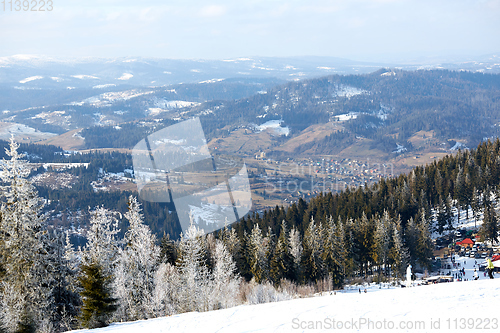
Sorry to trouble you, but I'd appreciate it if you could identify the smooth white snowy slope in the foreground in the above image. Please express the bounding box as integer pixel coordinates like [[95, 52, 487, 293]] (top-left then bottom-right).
[[71, 275, 500, 333]]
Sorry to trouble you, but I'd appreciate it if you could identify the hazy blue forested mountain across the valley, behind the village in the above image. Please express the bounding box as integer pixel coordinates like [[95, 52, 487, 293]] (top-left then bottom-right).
[[195, 69, 500, 153]]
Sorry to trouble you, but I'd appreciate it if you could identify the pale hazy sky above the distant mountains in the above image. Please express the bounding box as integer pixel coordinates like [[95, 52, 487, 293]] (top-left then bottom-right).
[[0, 0, 500, 61]]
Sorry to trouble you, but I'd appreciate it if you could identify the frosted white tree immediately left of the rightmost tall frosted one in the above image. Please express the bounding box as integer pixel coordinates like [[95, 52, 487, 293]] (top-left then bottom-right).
[[177, 224, 210, 312]]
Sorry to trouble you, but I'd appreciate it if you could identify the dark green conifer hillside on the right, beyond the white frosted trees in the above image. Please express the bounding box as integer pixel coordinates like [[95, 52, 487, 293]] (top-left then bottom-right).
[[228, 140, 500, 285]]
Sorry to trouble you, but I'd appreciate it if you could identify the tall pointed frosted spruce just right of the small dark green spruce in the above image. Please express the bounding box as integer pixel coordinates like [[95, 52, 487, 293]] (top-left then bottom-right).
[[113, 196, 160, 321]]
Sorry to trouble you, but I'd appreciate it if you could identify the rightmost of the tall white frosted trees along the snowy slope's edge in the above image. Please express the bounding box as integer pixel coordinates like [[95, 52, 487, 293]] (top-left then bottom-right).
[[211, 240, 240, 309]]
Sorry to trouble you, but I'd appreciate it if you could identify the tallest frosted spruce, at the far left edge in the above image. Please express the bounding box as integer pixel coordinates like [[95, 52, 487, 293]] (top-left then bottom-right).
[[0, 139, 51, 332]]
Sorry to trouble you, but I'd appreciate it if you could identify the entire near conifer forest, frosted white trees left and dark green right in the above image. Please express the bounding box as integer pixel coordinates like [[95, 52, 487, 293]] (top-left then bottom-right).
[[0, 136, 500, 332]]
